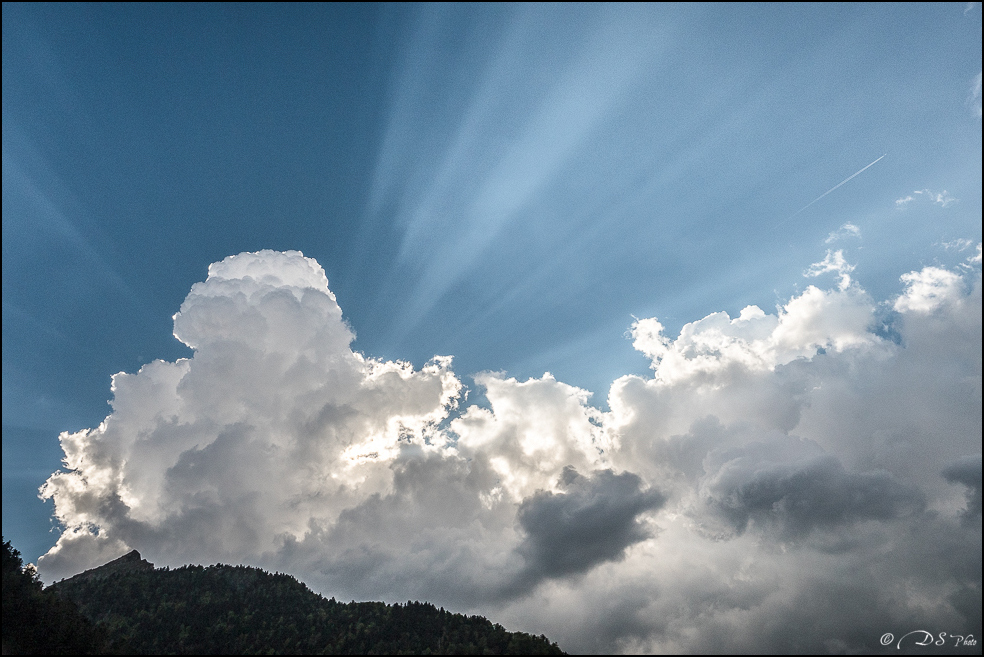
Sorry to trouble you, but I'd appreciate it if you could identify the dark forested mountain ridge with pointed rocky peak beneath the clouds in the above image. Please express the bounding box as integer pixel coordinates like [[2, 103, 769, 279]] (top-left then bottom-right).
[[3, 543, 564, 655]]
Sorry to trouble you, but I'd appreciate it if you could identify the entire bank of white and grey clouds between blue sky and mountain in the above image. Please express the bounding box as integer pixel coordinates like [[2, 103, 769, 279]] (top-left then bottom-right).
[[40, 251, 982, 652]]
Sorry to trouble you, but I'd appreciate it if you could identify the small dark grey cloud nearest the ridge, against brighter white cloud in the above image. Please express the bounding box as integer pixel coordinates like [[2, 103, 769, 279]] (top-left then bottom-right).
[[517, 467, 666, 580]]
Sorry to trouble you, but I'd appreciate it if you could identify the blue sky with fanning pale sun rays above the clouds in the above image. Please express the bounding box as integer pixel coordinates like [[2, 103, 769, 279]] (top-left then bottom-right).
[[3, 3, 981, 648]]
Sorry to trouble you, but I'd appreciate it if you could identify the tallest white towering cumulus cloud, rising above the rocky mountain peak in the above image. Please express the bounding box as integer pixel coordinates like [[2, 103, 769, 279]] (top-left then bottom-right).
[[45, 251, 461, 573]]
